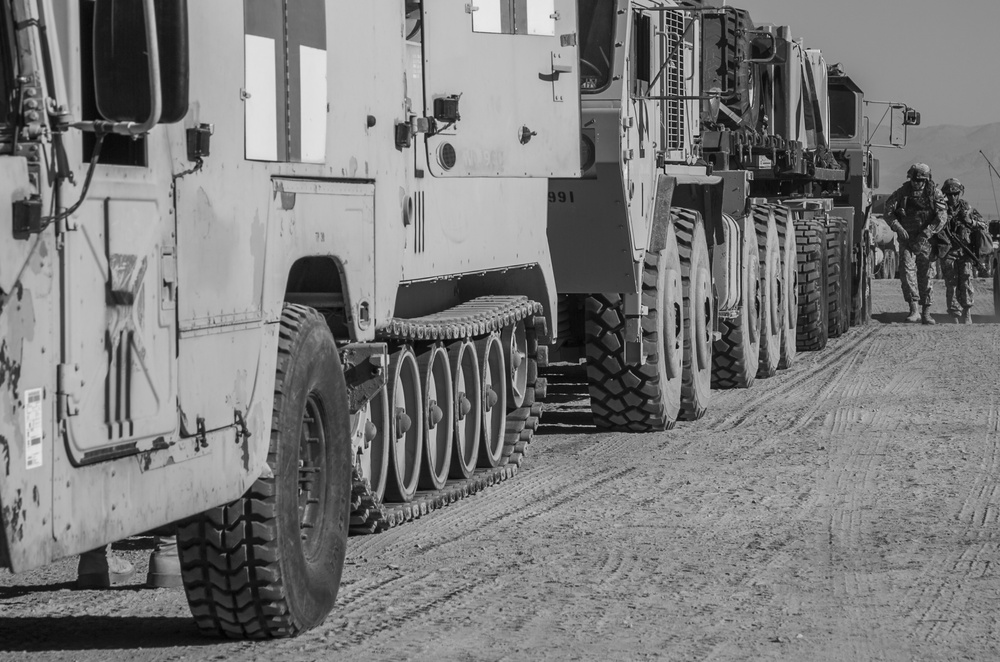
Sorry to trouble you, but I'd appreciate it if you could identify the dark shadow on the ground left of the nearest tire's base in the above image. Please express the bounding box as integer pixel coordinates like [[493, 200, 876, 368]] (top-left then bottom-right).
[[0, 616, 209, 652]]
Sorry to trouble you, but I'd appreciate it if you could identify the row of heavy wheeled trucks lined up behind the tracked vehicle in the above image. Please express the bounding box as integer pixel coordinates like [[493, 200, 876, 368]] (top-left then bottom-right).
[[548, 0, 918, 430]]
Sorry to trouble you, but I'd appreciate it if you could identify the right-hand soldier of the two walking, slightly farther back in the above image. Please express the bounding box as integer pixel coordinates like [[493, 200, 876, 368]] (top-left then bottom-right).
[[941, 179, 986, 324]]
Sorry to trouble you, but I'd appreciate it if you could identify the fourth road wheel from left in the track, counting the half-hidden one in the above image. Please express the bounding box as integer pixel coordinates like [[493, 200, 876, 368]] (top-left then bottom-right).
[[448, 340, 483, 478]]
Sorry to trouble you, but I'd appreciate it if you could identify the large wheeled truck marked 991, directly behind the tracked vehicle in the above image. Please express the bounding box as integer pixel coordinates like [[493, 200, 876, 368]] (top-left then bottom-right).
[[549, 0, 797, 430]]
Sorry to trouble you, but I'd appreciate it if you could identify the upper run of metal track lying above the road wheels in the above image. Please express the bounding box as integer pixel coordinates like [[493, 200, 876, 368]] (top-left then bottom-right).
[[378, 296, 544, 341]]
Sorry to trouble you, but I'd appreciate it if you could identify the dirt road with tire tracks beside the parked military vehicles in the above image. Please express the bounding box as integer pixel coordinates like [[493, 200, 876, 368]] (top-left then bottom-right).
[[0, 281, 1000, 662]]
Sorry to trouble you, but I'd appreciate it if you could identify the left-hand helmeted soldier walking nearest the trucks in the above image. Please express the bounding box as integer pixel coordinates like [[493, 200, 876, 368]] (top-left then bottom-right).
[[885, 163, 948, 324]]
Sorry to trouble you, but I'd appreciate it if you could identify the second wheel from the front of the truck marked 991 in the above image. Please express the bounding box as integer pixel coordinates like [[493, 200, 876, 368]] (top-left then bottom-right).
[[670, 208, 715, 421]]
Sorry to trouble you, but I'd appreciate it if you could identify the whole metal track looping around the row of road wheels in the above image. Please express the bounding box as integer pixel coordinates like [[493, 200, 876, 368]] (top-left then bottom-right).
[[350, 297, 547, 535]]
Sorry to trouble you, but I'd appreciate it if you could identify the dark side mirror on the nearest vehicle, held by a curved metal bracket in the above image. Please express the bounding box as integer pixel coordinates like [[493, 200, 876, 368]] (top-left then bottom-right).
[[94, 0, 190, 133]]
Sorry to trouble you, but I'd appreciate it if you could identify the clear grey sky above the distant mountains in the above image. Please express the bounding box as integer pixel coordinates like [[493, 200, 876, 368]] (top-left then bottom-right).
[[726, 0, 1000, 126]]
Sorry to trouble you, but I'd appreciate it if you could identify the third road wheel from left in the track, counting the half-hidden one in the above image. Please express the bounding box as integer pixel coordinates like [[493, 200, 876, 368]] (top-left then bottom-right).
[[417, 345, 455, 490]]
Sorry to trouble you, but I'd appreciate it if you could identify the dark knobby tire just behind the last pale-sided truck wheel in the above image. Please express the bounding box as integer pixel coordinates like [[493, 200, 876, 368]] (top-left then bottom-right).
[[795, 219, 828, 352]]
